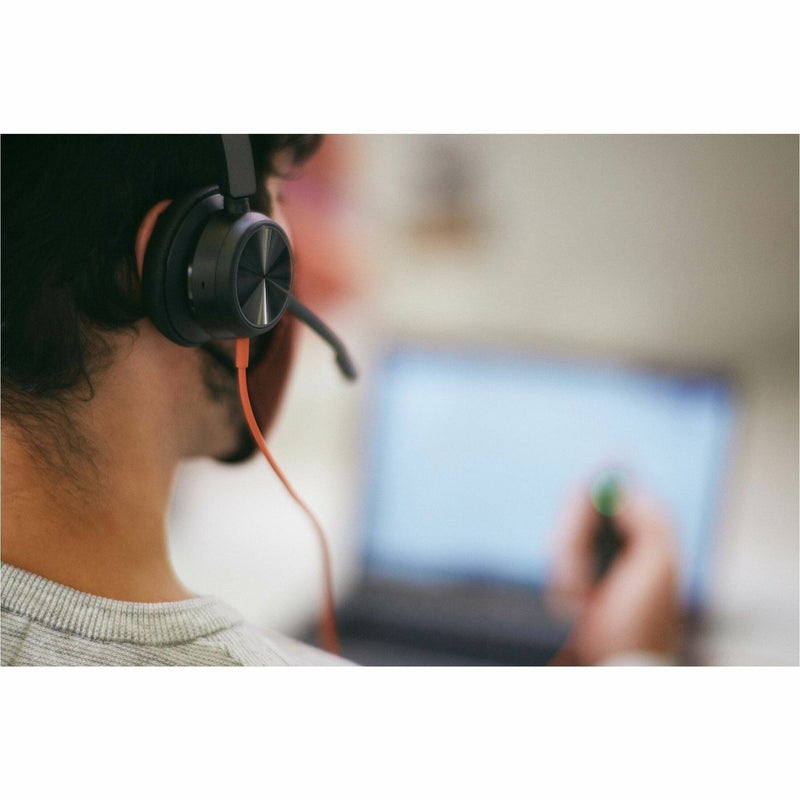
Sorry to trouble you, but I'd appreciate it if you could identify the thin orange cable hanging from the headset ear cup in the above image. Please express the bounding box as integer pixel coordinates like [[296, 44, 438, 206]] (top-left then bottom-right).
[[235, 339, 340, 655]]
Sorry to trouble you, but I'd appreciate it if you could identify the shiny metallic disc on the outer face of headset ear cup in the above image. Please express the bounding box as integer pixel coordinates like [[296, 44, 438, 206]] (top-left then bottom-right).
[[236, 225, 292, 328]]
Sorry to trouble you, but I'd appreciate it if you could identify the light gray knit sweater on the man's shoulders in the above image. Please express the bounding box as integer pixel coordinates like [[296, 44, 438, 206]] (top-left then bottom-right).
[[0, 564, 350, 666]]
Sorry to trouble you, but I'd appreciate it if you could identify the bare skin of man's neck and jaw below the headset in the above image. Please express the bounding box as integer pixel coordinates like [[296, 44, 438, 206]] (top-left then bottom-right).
[[2, 320, 247, 602]]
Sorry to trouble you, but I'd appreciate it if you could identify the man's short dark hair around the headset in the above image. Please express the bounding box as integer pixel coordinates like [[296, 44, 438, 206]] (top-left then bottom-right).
[[2, 134, 320, 421]]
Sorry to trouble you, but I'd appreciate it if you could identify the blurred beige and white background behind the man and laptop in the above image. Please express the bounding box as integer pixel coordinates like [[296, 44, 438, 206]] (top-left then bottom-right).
[[170, 135, 798, 664]]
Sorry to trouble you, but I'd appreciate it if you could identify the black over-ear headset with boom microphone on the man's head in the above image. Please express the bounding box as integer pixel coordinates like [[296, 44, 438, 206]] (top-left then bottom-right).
[[142, 134, 356, 380]]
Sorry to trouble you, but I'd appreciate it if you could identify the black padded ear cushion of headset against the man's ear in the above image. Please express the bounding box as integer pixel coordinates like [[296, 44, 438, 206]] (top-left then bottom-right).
[[142, 186, 223, 347]]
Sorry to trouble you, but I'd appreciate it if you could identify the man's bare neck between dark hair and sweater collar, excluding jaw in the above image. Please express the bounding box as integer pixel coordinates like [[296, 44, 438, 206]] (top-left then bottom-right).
[[2, 398, 191, 602]]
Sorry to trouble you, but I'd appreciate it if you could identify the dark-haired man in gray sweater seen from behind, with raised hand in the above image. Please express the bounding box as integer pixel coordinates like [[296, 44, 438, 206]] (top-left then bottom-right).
[[2, 136, 676, 665]]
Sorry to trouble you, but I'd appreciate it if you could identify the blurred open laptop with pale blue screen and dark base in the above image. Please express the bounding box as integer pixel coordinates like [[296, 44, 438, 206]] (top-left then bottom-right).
[[338, 346, 733, 666]]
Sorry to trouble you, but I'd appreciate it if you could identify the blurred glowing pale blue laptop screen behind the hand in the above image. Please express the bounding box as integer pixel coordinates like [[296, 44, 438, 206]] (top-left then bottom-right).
[[364, 349, 732, 604]]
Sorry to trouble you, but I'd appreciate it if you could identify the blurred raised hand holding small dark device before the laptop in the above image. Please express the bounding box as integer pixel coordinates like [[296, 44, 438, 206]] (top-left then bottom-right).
[[550, 489, 679, 664]]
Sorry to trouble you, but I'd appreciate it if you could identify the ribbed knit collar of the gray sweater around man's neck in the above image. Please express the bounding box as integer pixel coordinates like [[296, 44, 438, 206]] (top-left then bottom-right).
[[0, 564, 242, 645]]
